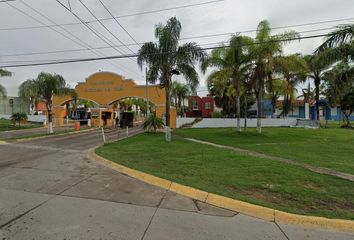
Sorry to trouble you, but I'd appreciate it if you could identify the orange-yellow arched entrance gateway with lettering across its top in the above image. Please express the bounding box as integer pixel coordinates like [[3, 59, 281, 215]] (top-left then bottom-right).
[[53, 72, 176, 128]]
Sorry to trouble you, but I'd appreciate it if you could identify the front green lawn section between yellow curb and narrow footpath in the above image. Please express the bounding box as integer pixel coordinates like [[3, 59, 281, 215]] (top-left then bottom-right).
[[96, 134, 354, 219]]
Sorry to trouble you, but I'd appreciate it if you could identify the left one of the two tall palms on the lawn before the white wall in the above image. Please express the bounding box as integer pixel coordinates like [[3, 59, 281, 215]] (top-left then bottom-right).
[[202, 36, 252, 132]]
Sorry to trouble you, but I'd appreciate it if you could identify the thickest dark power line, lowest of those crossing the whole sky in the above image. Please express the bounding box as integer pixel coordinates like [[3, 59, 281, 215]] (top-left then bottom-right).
[[0, 34, 328, 68]]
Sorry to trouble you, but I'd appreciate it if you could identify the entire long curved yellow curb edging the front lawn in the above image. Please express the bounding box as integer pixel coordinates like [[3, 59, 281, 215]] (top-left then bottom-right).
[[88, 147, 354, 232]]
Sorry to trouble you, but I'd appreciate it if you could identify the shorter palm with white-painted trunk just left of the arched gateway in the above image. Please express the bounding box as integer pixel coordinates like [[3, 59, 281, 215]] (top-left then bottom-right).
[[34, 72, 73, 134]]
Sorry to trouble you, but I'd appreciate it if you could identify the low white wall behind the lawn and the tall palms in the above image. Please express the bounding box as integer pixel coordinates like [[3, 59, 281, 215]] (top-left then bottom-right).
[[176, 118, 296, 128]]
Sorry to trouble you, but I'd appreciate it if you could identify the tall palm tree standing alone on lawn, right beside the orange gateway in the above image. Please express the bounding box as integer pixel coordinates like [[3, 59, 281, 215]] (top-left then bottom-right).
[[138, 17, 206, 141]]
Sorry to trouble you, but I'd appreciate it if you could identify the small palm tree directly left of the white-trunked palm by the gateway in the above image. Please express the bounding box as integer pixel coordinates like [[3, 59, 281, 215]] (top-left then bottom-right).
[[18, 79, 39, 113]]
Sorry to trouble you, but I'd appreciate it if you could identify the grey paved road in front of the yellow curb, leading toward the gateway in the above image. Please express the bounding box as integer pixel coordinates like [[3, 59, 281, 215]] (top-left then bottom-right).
[[0, 128, 354, 240]]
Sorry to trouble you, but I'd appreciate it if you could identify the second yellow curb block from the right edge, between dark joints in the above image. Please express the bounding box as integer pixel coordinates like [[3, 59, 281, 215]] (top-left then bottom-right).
[[206, 193, 274, 221]]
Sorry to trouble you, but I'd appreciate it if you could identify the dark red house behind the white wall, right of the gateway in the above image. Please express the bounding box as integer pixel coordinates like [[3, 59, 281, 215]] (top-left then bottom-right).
[[186, 96, 215, 118]]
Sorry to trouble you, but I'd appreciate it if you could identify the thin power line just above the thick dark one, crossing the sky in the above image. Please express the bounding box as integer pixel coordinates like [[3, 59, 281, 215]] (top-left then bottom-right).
[[0, 27, 334, 58]]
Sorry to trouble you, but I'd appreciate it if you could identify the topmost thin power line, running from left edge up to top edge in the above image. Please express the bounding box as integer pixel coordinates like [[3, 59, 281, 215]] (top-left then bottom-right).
[[0, 0, 225, 31]]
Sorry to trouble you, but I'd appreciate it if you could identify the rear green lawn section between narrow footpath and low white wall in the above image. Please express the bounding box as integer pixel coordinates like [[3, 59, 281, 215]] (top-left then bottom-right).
[[174, 128, 354, 174]]
